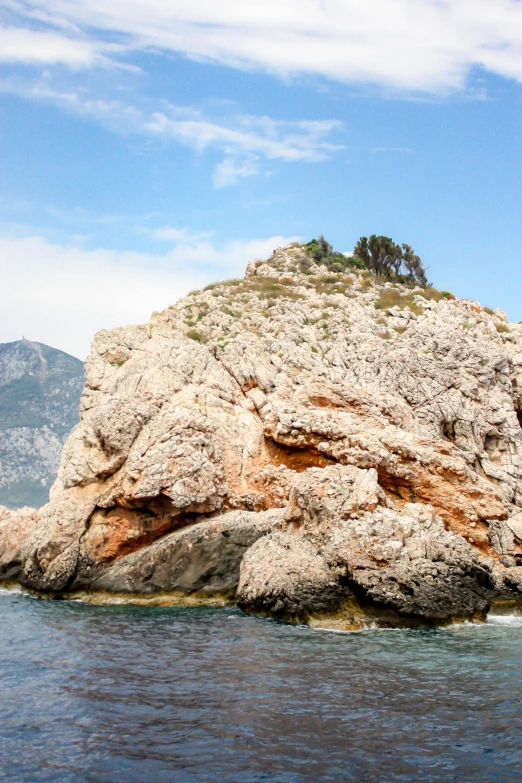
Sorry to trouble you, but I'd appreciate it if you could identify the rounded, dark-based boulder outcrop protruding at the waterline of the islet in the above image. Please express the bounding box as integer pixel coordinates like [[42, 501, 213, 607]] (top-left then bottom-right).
[[238, 466, 502, 621]]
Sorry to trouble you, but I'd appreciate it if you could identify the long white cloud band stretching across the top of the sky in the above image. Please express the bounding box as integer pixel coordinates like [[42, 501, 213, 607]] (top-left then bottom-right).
[[4, 0, 522, 92]]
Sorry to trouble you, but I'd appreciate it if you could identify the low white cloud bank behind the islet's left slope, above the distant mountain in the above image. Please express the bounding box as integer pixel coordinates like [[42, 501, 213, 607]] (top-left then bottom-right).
[[0, 230, 296, 359]]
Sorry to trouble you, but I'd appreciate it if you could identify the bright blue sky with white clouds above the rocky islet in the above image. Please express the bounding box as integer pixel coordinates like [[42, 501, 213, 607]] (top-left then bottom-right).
[[0, 0, 522, 359]]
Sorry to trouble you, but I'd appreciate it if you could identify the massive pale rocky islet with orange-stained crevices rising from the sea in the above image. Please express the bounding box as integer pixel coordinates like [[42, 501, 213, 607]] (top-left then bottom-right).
[[0, 245, 522, 627]]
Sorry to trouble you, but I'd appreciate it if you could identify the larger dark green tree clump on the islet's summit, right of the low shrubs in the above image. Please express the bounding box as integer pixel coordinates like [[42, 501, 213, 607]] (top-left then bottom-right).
[[353, 239, 429, 288]]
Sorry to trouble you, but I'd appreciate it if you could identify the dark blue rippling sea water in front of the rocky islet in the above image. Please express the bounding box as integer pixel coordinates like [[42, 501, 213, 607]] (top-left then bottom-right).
[[0, 593, 522, 783]]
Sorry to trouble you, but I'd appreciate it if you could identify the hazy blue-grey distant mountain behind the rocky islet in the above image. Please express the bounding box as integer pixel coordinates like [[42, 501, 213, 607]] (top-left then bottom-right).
[[0, 340, 83, 508]]
